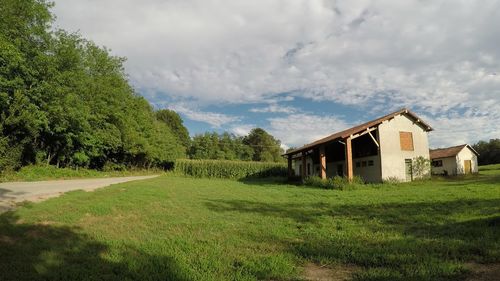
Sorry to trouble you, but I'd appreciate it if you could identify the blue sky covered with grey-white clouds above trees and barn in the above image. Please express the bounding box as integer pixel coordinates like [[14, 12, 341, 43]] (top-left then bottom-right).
[[54, 0, 500, 147]]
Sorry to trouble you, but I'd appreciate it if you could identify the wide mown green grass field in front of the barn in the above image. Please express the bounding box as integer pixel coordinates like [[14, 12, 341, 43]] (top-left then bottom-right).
[[0, 166, 500, 280]]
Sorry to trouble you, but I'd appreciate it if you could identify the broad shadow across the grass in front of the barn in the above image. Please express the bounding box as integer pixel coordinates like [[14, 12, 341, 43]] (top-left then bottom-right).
[[206, 199, 500, 281]]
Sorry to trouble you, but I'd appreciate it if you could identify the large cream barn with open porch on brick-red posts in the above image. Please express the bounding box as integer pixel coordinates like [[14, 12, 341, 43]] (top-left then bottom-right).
[[284, 108, 432, 182]]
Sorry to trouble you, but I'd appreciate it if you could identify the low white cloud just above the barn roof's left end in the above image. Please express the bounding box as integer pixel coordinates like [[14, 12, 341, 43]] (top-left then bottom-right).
[[269, 114, 353, 147]]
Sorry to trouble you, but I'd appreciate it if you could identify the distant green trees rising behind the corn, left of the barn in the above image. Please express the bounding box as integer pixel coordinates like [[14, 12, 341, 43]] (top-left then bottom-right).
[[188, 128, 284, 162]]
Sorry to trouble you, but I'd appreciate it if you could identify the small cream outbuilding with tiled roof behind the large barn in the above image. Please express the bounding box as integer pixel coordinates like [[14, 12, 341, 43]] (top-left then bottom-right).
[[429, 144, 479, 175]]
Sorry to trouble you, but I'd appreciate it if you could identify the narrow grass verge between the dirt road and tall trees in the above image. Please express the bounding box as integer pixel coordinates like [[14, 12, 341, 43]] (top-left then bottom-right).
[[0, 165, 161, 182]]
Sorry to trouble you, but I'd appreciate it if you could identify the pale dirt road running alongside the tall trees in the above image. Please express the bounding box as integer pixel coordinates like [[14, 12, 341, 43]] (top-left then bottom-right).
[[0, 176, 157, 213]]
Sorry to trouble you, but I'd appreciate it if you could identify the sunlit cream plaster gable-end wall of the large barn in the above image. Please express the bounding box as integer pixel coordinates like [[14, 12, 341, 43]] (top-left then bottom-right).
[[379, 115, 429, 181]]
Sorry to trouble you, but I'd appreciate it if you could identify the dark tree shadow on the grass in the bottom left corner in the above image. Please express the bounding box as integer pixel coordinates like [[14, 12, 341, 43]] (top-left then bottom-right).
[[0, 212, 188, 281]]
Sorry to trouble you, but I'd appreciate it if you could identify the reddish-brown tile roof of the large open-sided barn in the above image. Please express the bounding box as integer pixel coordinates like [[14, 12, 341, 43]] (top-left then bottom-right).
[[284, 108, 433, 155]]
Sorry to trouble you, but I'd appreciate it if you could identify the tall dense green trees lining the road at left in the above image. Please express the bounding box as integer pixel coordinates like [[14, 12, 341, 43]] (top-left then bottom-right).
[[0, 0, 185, 171]]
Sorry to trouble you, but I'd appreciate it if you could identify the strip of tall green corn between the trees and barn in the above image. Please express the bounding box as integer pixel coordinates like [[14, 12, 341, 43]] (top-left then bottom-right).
[[174, 159, 287, 179]]
